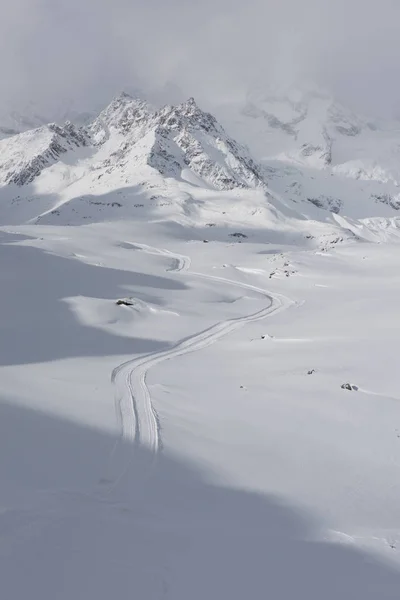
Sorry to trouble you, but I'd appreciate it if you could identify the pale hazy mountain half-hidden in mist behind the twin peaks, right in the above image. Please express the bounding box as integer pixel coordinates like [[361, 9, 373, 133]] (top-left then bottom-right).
[[217, 88, 400, 223]]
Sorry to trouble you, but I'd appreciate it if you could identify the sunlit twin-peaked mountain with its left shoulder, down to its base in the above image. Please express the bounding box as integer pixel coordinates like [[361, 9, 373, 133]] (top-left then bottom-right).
[[0, 93, 296, 235]]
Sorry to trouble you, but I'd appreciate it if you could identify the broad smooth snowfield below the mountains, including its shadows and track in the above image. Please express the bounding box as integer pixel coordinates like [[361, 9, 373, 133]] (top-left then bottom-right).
[[0, 221, 400, 600]]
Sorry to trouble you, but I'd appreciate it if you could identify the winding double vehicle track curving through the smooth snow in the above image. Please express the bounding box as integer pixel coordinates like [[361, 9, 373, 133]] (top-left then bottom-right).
[[104, 242, 294, 487]]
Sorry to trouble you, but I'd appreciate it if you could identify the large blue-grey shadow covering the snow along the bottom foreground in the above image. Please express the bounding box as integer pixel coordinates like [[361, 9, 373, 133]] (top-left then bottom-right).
[[0, 394, 400, 600]]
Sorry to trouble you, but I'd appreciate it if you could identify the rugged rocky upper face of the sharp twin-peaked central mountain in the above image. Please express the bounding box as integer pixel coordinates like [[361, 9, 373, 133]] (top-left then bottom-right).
[[90, 94, 265, 190]]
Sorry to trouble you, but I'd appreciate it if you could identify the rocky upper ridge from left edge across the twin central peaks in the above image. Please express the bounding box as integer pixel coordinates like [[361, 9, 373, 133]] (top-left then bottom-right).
[[0, 94, 265, 189]]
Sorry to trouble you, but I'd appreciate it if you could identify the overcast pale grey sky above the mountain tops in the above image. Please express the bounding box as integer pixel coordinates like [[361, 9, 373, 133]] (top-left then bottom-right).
[[0, 0, 400, 115]]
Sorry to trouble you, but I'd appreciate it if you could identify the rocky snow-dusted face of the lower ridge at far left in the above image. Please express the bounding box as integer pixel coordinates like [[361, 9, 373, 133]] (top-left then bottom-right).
[[0, 122, 90, 186]]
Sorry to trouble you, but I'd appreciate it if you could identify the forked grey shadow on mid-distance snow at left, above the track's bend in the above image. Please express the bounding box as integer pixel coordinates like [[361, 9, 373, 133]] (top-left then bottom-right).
[[0, 234, 186, 365]]
